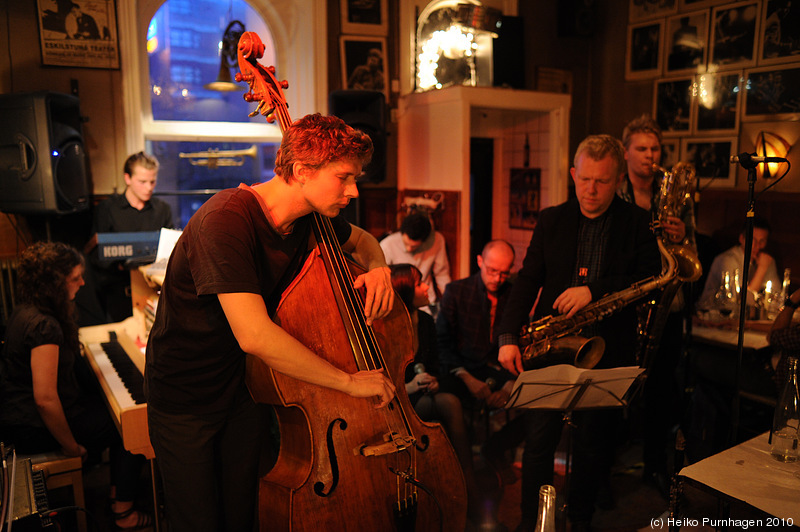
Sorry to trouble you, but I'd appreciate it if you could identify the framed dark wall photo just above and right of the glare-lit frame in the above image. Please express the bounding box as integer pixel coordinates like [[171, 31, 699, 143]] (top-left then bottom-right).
[[708, 2, 759, 68]]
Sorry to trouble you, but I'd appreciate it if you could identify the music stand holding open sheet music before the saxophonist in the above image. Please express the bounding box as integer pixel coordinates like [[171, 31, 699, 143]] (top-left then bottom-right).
[[505, 364, 644, 529]]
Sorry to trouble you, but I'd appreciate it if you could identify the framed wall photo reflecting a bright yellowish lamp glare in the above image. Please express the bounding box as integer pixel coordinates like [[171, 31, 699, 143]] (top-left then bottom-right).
[[694, 71, 742, 135]]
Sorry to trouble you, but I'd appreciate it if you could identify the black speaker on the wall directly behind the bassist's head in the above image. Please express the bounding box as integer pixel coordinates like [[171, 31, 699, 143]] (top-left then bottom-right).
[[329, 90, 386, 183]]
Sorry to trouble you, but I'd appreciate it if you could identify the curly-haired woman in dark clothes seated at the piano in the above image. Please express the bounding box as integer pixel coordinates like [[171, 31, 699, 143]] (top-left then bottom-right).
[[0, 242, 152, 530]]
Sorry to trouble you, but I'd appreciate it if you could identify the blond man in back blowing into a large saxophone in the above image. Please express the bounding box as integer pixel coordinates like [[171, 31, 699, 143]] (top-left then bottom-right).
[[617, 114, 699, 499]]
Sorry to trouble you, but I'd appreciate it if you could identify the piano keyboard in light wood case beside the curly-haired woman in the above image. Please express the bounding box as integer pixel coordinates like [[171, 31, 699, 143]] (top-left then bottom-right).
[[80, 318, 155, 459]]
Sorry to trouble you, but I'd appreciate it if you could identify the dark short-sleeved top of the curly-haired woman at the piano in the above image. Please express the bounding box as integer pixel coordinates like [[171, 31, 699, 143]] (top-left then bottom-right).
[[0, 304, 81, 427]]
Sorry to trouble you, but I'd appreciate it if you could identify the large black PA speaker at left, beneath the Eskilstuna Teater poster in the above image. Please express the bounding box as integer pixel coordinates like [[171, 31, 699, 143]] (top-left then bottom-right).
[[0, 92, 89, 214]]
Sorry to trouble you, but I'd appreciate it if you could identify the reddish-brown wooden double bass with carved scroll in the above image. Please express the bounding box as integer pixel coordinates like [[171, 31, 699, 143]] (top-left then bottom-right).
[[236, 32, 467, 532]]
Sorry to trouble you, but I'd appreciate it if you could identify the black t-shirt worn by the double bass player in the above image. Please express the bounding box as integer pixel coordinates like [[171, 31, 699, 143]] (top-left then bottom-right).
[[145, 186, 351, 414]]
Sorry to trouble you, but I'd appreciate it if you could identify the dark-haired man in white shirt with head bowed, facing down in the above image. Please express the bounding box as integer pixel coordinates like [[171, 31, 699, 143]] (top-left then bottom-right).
[[381, 212, 450, 316]]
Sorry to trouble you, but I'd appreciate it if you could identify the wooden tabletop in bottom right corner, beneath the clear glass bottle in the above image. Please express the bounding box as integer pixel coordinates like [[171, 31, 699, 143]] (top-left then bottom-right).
[[679, 432, 800, 528]]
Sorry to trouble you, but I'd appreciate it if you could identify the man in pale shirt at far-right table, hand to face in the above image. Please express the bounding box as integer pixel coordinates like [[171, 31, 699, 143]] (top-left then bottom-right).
[[697, 216, 781, 308]]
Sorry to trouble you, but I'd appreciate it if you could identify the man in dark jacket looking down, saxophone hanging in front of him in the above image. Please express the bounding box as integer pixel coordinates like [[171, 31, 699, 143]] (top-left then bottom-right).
[[498, 135, 661, 531]]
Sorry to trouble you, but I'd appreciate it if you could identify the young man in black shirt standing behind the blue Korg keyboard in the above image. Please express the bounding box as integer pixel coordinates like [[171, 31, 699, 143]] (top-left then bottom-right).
[[92, 152, 174, 323]]
